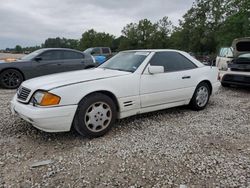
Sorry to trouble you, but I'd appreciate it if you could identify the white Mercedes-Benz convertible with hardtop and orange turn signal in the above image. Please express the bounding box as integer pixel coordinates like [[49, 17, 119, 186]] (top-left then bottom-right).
[[11, 50, 220, 137]]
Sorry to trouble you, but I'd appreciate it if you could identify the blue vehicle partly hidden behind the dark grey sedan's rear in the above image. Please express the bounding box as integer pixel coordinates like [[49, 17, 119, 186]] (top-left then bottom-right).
[[84, 47, 112, 64]]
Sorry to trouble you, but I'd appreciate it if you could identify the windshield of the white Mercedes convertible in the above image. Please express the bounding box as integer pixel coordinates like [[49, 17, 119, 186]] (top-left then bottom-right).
[[99, 52, 149, 72]]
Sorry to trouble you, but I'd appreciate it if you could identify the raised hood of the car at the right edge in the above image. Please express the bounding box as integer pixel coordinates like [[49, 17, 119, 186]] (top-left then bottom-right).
[[232, 37, 250, 57]]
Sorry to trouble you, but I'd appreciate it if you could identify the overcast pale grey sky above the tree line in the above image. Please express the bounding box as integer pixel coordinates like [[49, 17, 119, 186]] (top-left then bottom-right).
[[0, 0, 193, 49]]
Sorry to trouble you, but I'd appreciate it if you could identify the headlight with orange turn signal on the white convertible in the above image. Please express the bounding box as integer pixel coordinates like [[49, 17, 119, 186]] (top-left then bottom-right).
[[33, 91, 61, 106]]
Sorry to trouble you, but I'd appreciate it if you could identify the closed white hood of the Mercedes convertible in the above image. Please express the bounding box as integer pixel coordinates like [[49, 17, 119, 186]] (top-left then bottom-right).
[[22, 68, 132, 91]]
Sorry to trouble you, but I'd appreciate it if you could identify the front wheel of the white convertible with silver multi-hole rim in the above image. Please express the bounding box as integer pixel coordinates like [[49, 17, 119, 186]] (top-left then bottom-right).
[[73, 93, 117, 138]]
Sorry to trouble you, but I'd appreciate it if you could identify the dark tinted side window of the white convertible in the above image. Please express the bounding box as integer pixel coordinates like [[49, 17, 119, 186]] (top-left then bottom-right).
[[150, 52, 197, 72]]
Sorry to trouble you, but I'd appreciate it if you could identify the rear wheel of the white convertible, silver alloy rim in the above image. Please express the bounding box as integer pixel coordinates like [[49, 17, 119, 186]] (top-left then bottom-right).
[[189, 82, 211, 111]]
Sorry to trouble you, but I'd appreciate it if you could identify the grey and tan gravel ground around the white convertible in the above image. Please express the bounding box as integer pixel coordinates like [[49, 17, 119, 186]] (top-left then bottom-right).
[[0, 88, 250, 187]]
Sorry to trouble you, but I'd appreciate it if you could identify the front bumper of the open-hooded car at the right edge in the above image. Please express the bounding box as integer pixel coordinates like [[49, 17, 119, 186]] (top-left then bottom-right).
[[221, 71, 250, 87]]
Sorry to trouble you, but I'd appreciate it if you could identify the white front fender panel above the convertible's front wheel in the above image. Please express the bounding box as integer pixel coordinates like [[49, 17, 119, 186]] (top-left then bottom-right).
[[50, 74, 140, 105]]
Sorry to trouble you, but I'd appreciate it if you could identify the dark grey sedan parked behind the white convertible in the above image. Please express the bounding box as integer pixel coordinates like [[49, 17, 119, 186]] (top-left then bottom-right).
[[0, 48, 96, 89]]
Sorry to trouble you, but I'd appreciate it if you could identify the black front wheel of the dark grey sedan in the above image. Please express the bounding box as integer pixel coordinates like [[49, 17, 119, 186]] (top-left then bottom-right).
[[0, 69, 24, 89]]
